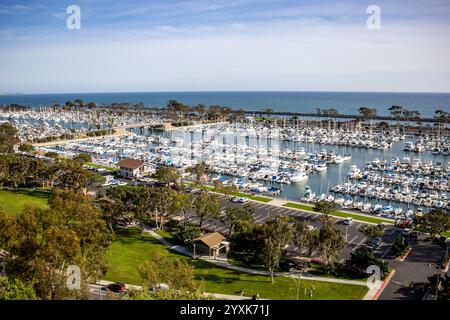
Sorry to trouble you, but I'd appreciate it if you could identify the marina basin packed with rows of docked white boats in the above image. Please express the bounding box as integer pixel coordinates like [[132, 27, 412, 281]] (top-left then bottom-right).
[[33, 123, 450, 218]]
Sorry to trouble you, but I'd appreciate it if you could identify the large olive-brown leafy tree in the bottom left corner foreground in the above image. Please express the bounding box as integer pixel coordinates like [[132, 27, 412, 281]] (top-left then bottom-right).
[[0, 190, 111, 299]]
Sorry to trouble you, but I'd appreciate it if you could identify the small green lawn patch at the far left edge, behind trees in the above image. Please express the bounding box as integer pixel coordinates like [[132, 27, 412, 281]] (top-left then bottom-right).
[[0, 189, 50, 214]]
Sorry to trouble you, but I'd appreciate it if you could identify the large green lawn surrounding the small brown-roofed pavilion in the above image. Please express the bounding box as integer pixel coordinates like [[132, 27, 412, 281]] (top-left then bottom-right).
[[104, 228, 368, 300]]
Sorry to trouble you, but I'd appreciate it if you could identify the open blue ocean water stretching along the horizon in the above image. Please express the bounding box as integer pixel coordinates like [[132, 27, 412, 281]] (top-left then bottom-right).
[[0, 92, 450, 117]]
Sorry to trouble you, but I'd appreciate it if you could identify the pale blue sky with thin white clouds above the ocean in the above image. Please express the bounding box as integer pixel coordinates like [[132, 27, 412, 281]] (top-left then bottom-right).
[[0, 0, 450, 93]]
